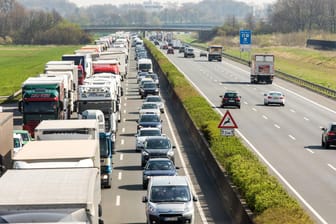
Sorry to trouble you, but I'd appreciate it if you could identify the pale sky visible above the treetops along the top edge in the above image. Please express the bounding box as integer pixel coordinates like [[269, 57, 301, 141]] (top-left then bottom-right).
[[69, 0, 276, 7]]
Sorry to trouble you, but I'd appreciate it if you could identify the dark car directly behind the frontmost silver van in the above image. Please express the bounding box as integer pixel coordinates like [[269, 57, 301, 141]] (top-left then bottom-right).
[[142, 158, 179, 189]]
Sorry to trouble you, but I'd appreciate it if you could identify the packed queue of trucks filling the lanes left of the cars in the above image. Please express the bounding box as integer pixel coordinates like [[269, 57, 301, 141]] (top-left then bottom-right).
[[0, 33, 129, 224]]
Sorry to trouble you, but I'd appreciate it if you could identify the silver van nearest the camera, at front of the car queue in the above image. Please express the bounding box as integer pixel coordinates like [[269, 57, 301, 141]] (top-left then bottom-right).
[[142, 176, 197, 223]]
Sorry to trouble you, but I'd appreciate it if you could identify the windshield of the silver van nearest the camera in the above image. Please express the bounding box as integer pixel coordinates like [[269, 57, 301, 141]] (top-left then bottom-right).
[[150, 186, 191, 202]]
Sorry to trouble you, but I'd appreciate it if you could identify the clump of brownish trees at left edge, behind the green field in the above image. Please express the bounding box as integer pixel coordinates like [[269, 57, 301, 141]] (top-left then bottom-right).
[[0, 0, 91, 44]]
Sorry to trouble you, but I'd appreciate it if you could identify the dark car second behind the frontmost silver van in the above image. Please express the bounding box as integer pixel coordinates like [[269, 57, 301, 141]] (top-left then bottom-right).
[[141, 136, 176, 167]]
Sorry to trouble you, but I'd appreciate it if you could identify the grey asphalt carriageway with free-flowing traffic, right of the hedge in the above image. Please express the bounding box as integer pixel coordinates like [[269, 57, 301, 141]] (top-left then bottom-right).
[[163, 46, 336, 223]]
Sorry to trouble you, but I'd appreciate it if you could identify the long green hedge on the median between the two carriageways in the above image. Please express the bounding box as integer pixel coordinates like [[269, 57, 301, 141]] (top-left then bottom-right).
[[145, 41, 313, 224]]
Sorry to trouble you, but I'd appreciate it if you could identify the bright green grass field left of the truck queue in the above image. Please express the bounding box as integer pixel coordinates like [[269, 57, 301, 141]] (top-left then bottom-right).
[[0, 45, 79, 96]]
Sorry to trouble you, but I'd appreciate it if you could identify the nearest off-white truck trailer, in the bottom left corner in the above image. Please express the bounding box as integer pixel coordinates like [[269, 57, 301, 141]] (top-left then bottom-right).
[[0, 168, 104, 224]]
